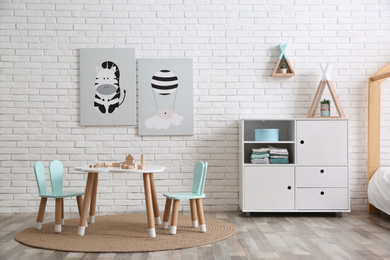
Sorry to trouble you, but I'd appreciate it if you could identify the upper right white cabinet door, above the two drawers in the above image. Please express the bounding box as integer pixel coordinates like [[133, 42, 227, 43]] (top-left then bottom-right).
[[297, 120, 348, 164]]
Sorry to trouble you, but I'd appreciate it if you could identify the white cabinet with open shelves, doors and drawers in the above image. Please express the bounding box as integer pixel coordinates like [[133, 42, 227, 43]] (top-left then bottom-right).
[[239, 119, 350, 214]]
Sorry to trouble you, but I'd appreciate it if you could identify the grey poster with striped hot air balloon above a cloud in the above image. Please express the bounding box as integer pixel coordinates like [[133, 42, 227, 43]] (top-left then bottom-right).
[[138, 59, 193, 135]]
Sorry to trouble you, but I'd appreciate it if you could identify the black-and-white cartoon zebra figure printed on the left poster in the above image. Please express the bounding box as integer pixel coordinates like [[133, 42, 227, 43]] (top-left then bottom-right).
[[94, 61, 126, 114]]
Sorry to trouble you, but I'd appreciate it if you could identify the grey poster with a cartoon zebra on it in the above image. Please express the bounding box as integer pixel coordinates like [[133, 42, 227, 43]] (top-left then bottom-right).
[[80, 48, 136, 125]]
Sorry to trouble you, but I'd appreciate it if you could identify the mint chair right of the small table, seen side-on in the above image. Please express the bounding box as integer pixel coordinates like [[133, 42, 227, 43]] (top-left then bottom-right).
[[163, 161, 207, 235]]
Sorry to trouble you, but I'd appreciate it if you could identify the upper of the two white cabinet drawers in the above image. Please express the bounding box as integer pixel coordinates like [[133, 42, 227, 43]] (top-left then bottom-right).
[[297, 167, 348, 188]]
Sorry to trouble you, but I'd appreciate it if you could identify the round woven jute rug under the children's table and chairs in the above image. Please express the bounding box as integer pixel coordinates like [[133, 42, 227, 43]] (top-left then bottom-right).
[[15, 214, 236, 253]]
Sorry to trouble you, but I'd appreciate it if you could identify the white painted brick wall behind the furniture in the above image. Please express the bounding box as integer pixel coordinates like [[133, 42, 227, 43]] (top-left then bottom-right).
[[0, 0, 390, 213]]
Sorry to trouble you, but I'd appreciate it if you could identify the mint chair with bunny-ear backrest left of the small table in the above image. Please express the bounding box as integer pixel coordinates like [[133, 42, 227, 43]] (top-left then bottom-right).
[[34, 160, 84, 233]]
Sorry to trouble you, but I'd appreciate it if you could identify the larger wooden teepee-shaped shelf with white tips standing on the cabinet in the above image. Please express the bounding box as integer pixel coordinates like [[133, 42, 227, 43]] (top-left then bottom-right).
[[307, 63, 345, 118]]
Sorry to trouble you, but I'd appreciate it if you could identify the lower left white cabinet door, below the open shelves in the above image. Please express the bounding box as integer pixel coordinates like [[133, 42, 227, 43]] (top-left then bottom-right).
[[244, 166, 294, 211]]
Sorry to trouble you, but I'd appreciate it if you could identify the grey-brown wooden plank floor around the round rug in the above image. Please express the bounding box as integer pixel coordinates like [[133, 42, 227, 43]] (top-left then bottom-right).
[[0, 212, 390, 260]]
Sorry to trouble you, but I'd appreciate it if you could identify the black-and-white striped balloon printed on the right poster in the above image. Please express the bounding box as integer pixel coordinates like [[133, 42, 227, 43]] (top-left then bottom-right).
[[152, 70, 179, 95]]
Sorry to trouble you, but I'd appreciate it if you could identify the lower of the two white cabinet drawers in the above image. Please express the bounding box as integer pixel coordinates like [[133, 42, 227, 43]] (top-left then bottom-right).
[[297, 188, 349, 210]]
